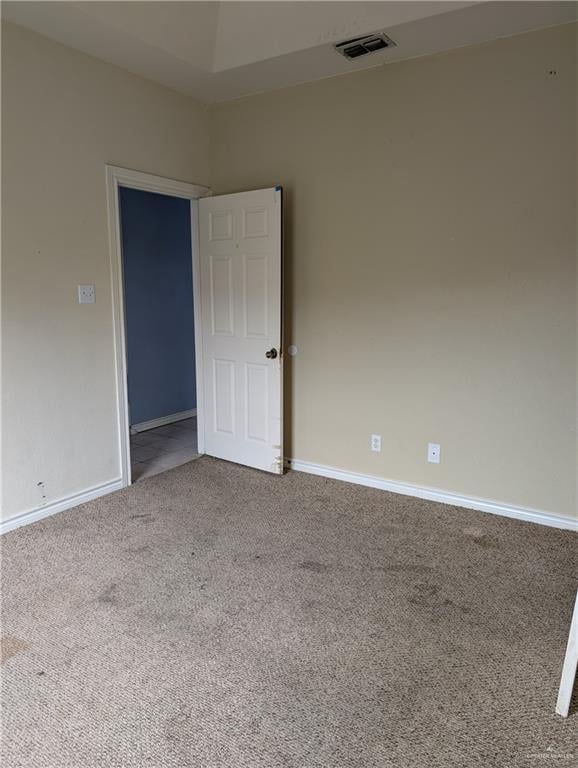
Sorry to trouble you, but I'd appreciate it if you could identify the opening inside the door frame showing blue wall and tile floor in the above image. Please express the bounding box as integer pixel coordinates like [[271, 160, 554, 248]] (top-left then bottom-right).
[[119, 186, 198, 482]]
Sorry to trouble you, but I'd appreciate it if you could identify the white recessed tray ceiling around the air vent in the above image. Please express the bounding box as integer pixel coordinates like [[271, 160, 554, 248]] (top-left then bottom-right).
[[2, 0, 577, 102]]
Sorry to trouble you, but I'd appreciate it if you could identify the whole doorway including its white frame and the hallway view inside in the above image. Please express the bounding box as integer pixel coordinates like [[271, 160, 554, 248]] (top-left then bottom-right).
[[107, 166, 209, 486]]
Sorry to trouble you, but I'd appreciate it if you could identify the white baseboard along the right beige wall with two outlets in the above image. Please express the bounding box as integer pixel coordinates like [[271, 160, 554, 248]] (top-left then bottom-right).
[[285, 459, 578, 531]]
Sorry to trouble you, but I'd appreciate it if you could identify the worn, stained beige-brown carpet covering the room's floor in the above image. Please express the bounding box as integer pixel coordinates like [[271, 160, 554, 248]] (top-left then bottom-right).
[[2, 458, 578, 768]]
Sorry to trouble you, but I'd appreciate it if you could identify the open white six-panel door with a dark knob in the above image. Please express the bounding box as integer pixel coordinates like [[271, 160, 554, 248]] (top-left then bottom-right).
[[199, 188, 283, 474]]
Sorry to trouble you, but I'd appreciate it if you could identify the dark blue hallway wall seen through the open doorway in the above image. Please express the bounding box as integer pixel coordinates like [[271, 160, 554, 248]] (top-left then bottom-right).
[[120, 188, 196, 424]]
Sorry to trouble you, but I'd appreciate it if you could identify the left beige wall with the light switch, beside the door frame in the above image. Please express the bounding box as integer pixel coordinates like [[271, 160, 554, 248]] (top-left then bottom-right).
[[2, 24, 208, 519]]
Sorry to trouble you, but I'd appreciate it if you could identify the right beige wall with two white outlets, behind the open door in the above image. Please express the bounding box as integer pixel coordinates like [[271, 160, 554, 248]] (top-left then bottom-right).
[[211, 26, 576, 516]]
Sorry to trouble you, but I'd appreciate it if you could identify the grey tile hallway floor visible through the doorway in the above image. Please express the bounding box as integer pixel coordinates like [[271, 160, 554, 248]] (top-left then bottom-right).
[[130, 418, 199, 476]]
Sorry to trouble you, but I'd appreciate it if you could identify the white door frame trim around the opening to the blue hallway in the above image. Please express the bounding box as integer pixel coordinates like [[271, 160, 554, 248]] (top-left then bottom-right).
[[106, 165, 211, 488]]
